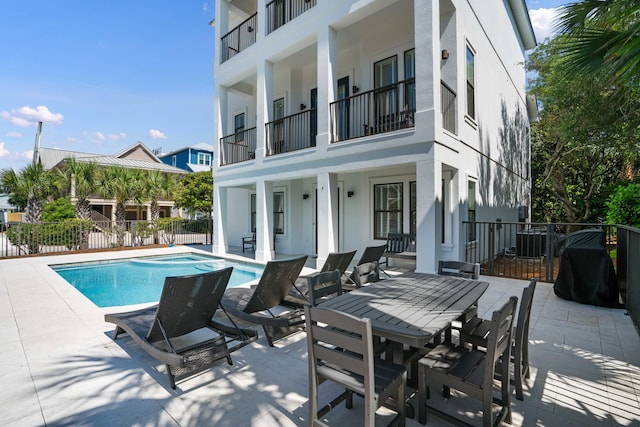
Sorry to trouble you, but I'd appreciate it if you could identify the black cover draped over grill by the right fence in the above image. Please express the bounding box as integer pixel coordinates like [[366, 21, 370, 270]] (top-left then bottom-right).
[[553, 230, 621, 307]]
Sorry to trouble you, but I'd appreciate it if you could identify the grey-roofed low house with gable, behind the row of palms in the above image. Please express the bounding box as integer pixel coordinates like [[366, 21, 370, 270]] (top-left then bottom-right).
[[34, 142, 185, 221]]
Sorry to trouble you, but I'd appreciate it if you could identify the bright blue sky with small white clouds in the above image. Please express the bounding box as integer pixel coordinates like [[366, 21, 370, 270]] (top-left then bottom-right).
[[0, 0, 569, 170]]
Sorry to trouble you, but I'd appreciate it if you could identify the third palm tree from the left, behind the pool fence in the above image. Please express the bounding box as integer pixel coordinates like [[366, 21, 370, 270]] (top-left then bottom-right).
[[97, 166, 142, 246]]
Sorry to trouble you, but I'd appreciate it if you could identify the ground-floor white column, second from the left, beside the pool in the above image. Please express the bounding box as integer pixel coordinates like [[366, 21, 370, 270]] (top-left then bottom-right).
[[256, 181, 275, 261]]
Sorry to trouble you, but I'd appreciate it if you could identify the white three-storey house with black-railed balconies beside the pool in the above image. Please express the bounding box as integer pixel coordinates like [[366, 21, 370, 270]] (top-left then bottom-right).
[[212, 0, 536, 272]]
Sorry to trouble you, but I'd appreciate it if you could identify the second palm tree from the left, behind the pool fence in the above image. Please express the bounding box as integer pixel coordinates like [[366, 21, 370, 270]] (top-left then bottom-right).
[[58, 159, 99, 220]]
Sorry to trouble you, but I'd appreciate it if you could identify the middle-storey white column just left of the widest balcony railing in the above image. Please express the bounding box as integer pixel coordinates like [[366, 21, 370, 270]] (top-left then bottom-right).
[[316, 26, 337, 150]]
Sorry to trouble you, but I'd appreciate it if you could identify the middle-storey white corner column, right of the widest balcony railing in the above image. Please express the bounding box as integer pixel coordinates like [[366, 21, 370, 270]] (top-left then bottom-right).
[[414, 1, 440, 141]]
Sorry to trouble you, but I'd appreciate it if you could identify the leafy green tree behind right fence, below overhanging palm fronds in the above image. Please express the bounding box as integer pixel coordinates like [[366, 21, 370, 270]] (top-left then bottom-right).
[[527, 36, 640, 222]]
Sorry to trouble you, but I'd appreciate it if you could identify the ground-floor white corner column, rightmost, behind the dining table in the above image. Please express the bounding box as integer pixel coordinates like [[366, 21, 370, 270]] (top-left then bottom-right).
[[416, 155, 442, 273]]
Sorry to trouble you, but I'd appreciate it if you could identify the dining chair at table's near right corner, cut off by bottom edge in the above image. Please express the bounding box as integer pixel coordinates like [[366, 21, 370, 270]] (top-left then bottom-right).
[[418, 297, 518, 427]]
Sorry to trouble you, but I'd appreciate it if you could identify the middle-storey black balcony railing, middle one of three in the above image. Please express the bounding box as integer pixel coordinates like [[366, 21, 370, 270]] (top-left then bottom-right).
[[265, 108, 318, 156]]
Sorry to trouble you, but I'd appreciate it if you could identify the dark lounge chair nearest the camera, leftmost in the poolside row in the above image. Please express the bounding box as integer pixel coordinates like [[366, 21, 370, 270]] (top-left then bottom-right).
[[104, 267, 258, 389]]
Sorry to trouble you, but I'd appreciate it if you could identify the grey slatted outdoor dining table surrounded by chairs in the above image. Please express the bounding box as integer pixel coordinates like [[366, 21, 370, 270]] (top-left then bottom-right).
[[320, 272, 489, 363]]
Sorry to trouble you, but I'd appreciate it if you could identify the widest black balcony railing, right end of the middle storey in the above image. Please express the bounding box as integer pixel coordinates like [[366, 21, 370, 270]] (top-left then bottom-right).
[[330, 79, 416, 142]]
